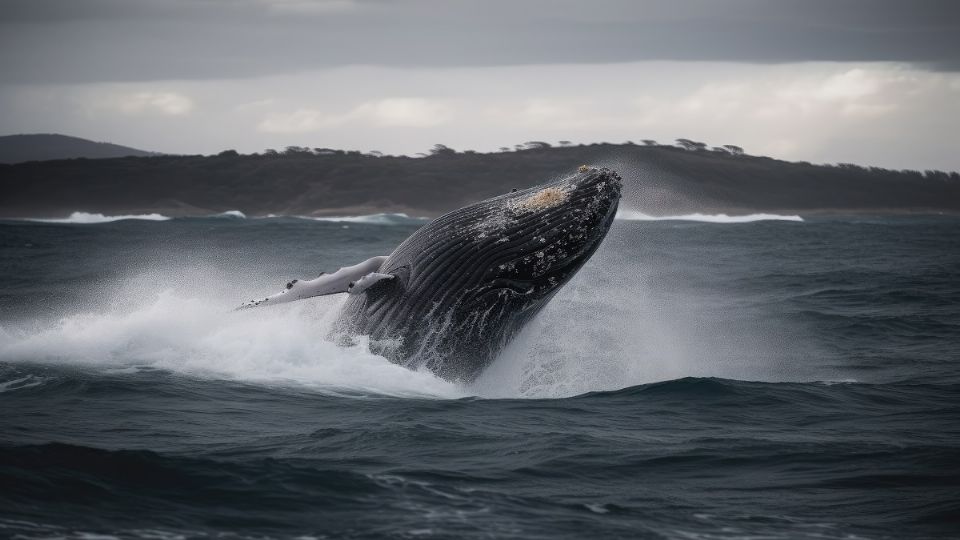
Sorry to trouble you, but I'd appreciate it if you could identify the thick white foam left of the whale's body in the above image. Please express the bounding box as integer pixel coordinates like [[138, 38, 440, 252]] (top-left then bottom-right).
[[0, 291, 465, 398]]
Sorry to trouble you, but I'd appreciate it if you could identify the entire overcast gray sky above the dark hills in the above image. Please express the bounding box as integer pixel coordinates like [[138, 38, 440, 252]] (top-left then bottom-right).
[[0, 0, 960, 170]]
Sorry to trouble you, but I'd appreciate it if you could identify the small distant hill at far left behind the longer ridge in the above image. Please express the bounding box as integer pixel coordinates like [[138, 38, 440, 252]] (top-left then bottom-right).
[[0, 134, 156, 163]]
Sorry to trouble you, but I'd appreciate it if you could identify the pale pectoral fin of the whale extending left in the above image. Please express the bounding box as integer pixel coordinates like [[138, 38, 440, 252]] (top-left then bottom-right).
[[237, 256, 393, 309]]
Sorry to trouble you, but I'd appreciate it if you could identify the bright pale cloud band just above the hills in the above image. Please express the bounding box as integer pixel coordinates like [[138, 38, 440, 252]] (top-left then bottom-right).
[[0, 62, 960, 170]]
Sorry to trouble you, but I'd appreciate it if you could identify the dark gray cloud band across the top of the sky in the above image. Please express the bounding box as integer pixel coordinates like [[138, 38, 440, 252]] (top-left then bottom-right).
[[0, 0, 960, 84]]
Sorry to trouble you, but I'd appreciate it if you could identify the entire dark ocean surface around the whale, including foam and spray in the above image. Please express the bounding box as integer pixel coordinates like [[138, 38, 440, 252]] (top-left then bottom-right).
[[0, 212, 960, 540]]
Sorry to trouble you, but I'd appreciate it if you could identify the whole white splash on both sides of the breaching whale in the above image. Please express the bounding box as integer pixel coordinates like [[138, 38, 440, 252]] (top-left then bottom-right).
[[0, 217, 816, 398]]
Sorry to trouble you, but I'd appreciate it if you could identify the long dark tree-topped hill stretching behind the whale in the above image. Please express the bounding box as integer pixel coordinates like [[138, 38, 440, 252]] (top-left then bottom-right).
[[0, 143, 960, 217]]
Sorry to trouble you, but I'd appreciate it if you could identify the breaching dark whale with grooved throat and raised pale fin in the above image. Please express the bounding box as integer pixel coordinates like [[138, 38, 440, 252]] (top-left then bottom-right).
[[239, 166, 621, 382]]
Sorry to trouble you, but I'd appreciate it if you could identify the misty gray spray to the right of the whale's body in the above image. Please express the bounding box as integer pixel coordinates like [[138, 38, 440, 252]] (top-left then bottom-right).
[[475, 219, 816, 398]]
